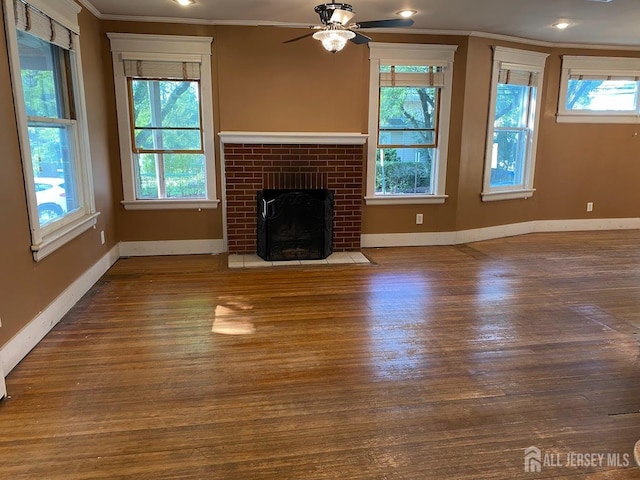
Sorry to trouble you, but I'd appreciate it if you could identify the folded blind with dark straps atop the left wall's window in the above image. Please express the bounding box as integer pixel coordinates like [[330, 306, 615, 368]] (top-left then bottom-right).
[[14, 0, 78, 50]]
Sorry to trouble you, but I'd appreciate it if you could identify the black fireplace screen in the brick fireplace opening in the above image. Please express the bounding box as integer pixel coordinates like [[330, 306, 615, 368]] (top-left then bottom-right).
[[257, 189, 333, 261]]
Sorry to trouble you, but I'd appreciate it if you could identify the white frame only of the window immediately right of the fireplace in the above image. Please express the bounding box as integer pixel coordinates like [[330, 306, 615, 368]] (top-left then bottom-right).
[[365, 42, 458, 205]]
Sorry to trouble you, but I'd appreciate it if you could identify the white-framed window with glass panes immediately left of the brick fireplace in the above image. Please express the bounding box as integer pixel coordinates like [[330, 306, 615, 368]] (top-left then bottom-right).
[[108, 33, 218, 209]]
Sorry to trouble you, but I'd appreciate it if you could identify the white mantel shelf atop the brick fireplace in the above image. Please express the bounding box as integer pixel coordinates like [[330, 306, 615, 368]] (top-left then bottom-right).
[[218, 132, 369, 145]]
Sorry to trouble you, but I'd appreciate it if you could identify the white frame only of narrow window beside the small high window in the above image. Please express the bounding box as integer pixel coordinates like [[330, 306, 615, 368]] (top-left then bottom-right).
[[481, 46, 549, 202]]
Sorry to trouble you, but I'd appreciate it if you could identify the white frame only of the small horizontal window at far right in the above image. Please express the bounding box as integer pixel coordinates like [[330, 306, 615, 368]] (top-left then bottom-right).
[[556, 55, 640, 123]]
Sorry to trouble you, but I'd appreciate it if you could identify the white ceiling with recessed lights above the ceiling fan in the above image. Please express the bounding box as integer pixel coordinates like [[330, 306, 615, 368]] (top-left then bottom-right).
[[79, 0, 640, 47]]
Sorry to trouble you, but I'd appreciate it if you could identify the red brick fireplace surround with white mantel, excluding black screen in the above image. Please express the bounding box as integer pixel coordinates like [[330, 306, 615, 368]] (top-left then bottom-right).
[[220, 132, 366, 254]]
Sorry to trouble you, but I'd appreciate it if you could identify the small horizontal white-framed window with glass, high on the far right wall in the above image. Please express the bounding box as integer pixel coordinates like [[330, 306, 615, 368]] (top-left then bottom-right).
[[557, 55, 640, 123]]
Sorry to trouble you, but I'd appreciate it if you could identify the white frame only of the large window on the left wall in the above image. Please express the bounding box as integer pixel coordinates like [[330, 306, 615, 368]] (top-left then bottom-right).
[[3, 0, 99, 262]]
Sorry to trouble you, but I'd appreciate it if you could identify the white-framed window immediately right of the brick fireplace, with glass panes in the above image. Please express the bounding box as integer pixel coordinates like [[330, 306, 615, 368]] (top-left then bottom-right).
[[365, 42, 456, 204]]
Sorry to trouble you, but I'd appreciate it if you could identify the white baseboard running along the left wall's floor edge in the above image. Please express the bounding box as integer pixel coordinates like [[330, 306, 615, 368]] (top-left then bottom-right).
[[0, 245, 119, 375]]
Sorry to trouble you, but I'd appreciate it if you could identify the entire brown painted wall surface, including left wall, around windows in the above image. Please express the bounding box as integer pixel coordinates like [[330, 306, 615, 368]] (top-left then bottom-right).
[[0, 6, 640, 352]]
